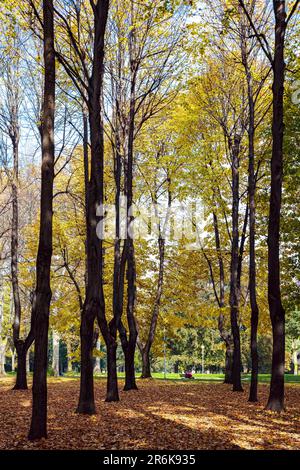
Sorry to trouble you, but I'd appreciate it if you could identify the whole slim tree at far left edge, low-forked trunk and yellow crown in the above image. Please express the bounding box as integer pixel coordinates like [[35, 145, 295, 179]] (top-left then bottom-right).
[[0, 4, 33, 390]]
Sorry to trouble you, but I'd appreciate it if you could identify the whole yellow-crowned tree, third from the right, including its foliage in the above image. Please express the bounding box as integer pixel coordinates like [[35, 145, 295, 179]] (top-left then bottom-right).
[[188, 59, 248, 391]]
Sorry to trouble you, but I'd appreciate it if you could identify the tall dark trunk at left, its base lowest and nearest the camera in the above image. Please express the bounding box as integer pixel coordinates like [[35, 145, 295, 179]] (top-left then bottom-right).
[[28, 0, 55, 440]]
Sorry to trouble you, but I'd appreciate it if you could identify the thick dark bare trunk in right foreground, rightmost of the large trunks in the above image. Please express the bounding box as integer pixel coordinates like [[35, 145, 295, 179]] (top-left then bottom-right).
[[267, 0, 286, 412]]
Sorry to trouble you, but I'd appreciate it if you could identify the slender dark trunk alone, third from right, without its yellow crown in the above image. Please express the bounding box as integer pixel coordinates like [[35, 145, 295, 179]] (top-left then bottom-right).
[[230, 135, 243, 392]]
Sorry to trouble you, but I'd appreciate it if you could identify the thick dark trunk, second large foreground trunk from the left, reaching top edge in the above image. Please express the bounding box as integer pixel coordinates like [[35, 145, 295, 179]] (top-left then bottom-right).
[[77, 0, 109, 414]]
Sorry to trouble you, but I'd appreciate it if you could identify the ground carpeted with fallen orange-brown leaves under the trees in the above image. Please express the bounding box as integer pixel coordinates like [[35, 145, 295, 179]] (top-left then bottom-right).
[[0, 377, 300, 450]]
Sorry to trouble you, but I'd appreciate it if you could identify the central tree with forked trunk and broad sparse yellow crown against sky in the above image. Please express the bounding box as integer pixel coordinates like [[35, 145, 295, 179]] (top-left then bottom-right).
[[106, 0, 183, 390]]
